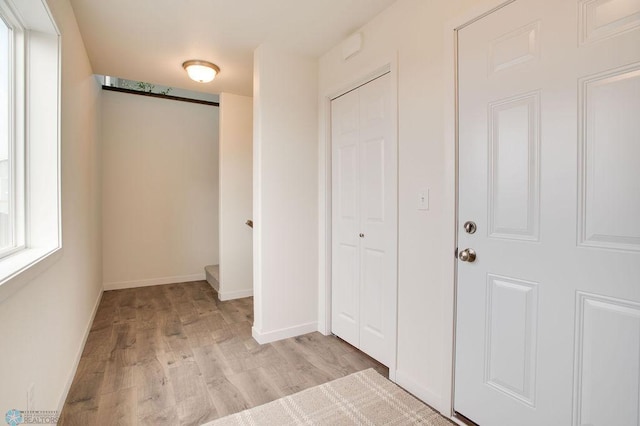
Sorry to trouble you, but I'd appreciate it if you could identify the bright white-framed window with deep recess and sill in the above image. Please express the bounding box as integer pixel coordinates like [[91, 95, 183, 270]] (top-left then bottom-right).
[[0, 0, 61, 301]]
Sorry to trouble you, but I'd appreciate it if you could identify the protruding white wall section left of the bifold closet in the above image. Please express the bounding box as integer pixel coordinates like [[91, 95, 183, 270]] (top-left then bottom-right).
[[253, 44, 318, 343]]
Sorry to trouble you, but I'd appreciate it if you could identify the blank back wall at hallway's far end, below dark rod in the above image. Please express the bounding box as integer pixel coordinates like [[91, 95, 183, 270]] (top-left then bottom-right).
[[102, 92, 219, 290]]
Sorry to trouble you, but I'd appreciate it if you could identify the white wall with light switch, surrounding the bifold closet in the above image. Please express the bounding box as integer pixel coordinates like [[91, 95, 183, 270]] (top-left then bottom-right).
[[319, 0, 492, 414]]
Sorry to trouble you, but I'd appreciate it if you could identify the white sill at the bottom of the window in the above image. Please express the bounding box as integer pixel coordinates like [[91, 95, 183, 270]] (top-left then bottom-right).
[[0, 247, 62, 303]]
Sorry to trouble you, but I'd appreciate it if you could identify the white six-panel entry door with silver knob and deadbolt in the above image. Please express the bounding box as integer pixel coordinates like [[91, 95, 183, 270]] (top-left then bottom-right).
[[454, 0, 640, 426]]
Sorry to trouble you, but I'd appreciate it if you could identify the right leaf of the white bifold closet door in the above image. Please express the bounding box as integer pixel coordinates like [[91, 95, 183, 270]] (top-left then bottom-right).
[[358, 74, 398, 365]]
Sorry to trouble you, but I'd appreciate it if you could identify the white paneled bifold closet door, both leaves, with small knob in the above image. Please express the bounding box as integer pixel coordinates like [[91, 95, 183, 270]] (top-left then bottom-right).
[[331, 74, 397, 365]]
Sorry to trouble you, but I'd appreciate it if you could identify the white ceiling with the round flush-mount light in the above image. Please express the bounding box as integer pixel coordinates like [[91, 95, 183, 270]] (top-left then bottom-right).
[[71, 0, 395, 96]]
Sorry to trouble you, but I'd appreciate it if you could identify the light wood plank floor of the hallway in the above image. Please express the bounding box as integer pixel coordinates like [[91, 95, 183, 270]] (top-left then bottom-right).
[[59, 281, 388, 426]]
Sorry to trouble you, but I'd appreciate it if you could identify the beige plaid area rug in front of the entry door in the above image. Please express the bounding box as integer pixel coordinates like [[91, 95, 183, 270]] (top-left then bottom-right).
[[205, 368, 453, 426]]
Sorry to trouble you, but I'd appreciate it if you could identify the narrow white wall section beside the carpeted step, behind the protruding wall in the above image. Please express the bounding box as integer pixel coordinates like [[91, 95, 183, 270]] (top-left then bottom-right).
[[218, 93, 253, 300]]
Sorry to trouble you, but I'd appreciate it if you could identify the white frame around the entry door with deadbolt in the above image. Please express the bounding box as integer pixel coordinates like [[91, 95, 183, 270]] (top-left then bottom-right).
[[443, 0, 516, 420]]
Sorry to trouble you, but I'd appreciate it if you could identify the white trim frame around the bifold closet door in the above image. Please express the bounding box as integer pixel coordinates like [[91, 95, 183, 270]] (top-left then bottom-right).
[[318, 58, 399, 382]]
